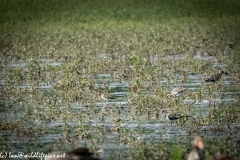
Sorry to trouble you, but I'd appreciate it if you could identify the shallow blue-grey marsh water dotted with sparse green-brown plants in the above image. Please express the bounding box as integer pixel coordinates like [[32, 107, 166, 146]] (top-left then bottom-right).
[[0, 52, 240, 159]]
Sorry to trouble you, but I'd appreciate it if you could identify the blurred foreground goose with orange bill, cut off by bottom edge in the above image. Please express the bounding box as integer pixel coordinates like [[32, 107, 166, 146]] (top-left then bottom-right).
[[187, 136, 240, 160]]
